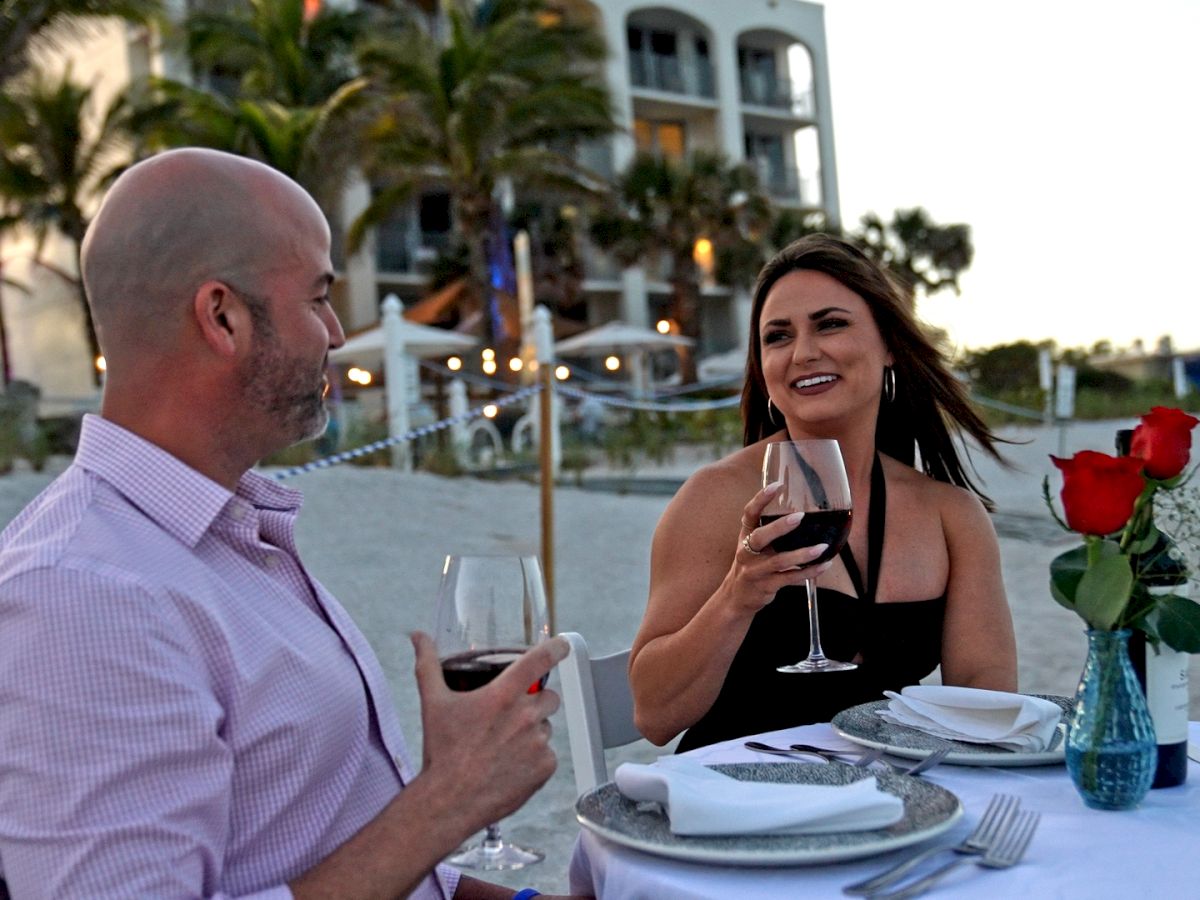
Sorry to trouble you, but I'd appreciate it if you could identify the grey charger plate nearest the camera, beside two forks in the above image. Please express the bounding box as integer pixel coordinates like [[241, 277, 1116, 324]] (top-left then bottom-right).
[[575, 762, 962, 866]]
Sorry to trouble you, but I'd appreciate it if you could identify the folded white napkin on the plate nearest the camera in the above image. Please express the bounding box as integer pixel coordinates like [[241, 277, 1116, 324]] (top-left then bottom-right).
[[616, 756, 904, 834]]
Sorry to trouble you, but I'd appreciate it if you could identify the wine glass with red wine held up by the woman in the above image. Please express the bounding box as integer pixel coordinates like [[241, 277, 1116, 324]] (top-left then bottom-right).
[[760, 440, 858, 672]]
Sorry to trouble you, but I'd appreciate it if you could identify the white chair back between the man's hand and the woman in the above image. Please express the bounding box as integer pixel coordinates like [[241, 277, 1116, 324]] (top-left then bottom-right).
[[558, 631, 642, 796]]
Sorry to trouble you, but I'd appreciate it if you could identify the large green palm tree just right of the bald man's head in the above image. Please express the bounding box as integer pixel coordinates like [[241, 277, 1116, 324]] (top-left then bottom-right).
[[350, 0, 616, 338]]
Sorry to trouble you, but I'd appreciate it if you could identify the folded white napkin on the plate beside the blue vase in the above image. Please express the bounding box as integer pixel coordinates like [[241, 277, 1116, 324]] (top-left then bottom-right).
[[878, 684, 1062, 752]]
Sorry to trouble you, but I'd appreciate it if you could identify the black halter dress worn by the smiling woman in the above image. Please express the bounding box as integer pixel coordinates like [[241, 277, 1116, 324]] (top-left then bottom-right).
[[677, 456, 946, 752]]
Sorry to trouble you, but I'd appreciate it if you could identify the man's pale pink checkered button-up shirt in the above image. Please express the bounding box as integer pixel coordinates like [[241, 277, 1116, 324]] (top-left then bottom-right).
[[0, 416, 457, 900]]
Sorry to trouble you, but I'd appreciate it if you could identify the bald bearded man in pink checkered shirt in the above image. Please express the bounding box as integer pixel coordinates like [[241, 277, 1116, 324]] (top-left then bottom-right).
[[0, 149, 566, 899]]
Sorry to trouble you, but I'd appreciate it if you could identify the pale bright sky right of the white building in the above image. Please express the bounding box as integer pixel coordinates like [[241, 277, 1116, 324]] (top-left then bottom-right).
[[823, 0, 1200, 360]]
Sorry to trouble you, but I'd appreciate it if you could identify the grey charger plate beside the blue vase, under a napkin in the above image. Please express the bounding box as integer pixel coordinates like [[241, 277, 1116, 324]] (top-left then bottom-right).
[[833, 694, 1075, 766]]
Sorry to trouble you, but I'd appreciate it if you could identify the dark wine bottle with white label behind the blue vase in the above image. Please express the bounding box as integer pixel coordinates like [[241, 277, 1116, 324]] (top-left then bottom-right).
[[1117, 430, 1189, 788]]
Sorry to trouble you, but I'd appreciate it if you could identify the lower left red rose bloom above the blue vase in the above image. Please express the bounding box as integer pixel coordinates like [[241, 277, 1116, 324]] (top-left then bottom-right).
[[1050, 450, 1146, 535]]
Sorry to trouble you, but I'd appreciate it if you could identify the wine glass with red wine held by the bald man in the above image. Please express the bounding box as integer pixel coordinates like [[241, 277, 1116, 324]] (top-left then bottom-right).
[[433, 554, 550, 870]]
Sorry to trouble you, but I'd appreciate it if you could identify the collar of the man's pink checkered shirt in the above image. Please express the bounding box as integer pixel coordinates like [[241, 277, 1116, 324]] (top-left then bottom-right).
[[74, 414, 301, 547]]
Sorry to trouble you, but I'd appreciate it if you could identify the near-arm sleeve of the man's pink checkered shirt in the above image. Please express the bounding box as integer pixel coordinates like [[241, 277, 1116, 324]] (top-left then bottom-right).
[[0, 566, 292, 900]]
